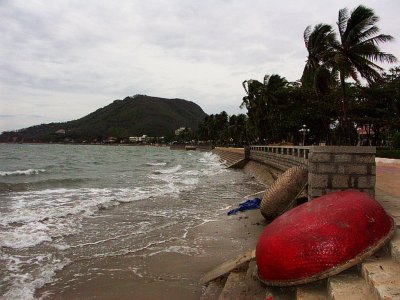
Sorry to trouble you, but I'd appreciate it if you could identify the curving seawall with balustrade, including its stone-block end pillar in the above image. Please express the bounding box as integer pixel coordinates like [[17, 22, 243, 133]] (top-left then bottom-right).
[[213, 146, 376, 200]]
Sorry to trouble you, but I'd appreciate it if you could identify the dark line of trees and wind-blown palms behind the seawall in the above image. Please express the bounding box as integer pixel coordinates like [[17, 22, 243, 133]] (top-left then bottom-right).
[[198, 5, 400, 145]]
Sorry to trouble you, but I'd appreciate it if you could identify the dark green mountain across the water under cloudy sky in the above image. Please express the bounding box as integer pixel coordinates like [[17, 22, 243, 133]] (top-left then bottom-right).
[[0, 95, 206, 142]]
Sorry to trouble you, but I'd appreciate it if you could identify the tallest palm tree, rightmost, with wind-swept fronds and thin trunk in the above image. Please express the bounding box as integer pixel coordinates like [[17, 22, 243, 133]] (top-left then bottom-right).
[[332, 5, 397, 142]]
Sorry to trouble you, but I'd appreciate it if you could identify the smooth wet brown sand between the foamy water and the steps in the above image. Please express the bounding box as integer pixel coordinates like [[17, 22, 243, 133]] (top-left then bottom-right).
[[37, 210, 266, 299]]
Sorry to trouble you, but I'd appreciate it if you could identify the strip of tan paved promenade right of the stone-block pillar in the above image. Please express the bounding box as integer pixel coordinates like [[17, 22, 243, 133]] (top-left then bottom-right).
[[375, 158, 400, 227]]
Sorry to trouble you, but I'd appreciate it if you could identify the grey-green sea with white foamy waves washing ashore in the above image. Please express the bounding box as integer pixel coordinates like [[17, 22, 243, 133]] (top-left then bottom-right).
[[0, 144, 259, 299]]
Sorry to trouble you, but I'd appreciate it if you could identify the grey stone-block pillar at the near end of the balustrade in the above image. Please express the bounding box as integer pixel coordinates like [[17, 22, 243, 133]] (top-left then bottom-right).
[[308, 146, 376, 200]]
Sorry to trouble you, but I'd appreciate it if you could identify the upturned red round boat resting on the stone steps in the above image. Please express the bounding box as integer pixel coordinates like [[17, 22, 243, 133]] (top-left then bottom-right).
[[256, 190, 395, 286]]
